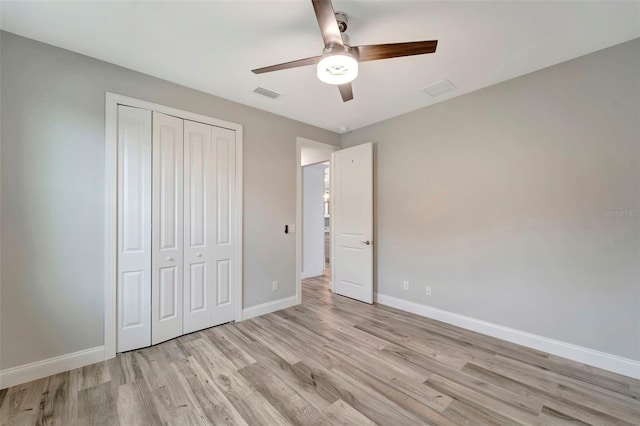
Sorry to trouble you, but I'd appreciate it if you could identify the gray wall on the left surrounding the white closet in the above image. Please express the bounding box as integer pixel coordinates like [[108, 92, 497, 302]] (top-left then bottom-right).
[[0, 32, 340, 369]]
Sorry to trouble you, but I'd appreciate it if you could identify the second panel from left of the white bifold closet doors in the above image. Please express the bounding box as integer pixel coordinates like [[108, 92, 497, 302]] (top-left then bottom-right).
[[151, 112, 184, 345]]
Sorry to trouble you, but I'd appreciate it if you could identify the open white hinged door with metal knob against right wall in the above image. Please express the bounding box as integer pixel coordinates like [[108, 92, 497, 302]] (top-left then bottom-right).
[[331, 142, 373, 303]]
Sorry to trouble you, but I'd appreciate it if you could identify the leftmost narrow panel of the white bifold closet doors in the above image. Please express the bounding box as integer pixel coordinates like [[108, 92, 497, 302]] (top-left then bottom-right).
[[116, 106, 151, 352]]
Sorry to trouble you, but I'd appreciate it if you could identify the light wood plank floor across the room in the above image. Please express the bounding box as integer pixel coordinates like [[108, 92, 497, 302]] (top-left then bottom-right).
[[0, 278, 640, 426]]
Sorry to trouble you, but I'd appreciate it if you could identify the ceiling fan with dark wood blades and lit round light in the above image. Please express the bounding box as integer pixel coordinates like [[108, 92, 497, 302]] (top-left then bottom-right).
[[251, 0, 438, 102]]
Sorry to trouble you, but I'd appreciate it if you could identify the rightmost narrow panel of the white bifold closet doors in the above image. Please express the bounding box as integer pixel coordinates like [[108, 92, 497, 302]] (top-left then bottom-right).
[[212, 127, 236, 325]]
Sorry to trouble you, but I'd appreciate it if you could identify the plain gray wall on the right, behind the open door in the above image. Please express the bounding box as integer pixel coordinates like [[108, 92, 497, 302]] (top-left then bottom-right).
[[342, 40, 640, 360]]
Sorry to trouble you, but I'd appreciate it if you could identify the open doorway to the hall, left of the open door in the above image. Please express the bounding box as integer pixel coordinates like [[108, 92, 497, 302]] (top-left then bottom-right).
[[296, 138, 340, 303]]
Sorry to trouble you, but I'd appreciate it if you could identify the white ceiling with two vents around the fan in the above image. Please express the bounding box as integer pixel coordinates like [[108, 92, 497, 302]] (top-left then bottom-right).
[[0, 0, 640, 132]]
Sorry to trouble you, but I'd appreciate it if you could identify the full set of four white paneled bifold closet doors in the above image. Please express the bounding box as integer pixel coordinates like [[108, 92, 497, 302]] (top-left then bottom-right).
[[117, 106, 238, 352]]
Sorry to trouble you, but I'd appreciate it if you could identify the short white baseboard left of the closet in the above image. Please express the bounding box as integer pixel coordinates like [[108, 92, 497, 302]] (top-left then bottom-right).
[[0, 346, 104, 389]]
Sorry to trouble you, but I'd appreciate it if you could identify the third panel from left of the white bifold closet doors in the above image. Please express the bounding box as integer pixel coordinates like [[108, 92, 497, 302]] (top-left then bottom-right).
[[184, 120, 216, 333]]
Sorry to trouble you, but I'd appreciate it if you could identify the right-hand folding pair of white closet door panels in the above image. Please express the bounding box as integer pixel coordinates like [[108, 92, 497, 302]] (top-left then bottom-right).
[[184, 120, 236, 333]]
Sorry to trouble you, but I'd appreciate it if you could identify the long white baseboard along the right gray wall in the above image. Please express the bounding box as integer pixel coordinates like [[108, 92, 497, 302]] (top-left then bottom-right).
[[376, 293, 640, 379]]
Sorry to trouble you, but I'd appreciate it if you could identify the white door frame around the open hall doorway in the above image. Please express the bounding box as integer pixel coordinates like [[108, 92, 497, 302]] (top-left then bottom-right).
[[296, 137, 340, 304]]
